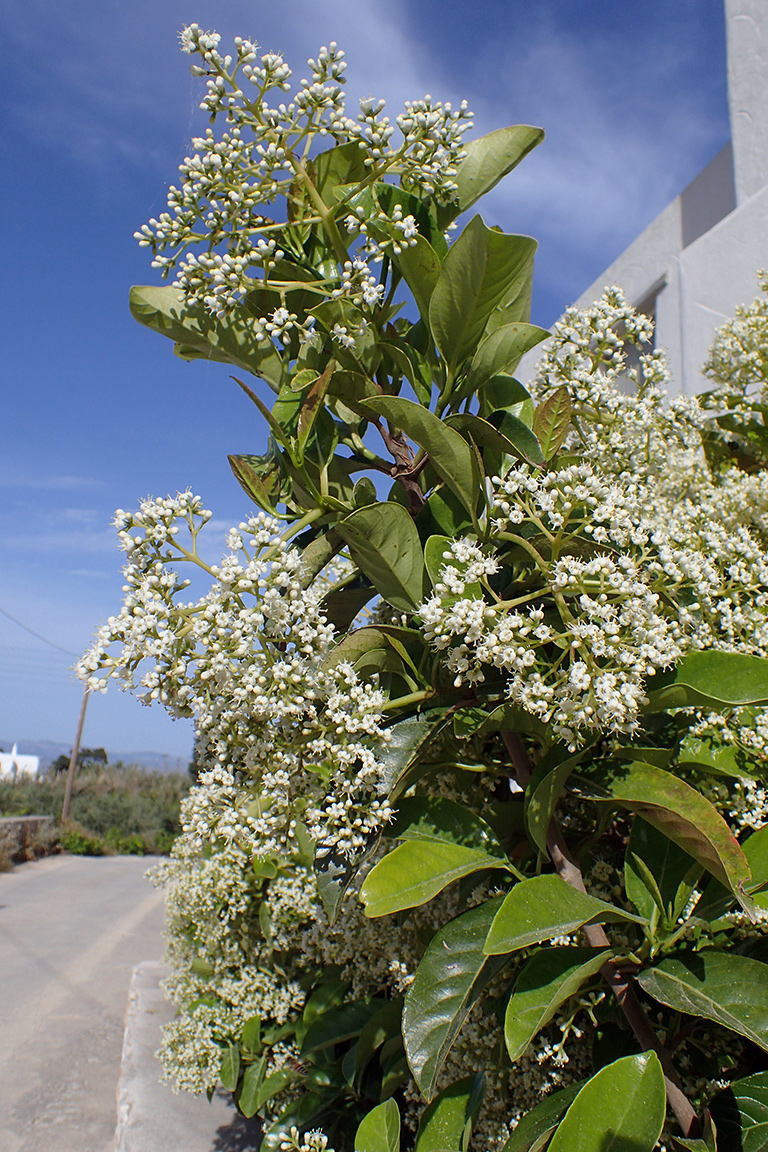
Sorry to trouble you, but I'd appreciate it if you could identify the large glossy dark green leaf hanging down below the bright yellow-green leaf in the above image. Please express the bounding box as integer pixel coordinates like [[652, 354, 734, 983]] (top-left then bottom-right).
[[403, 896, 505, 1100]]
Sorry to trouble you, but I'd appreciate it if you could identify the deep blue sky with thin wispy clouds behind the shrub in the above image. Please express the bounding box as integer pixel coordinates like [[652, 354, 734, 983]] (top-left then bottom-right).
[[0, 0, 729, 756]]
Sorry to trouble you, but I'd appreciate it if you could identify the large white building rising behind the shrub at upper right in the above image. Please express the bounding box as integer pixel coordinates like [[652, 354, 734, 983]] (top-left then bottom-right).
[[543, 0, 768, 393]]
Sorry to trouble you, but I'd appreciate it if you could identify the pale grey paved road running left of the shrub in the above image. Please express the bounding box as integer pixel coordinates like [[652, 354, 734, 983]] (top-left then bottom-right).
[[0, 856, 162, 1152]]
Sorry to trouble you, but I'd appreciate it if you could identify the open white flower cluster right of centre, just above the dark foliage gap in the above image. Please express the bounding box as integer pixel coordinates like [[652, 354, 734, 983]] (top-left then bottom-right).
[[419, 497, 684, 745]]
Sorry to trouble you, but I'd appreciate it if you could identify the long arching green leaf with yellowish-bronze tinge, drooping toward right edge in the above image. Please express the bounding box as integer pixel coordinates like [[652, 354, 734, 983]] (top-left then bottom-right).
[[575, 760, 750, 908]]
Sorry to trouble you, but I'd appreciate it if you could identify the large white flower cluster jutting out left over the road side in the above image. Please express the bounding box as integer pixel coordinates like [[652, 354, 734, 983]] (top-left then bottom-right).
[[79, 493, 390, 856]]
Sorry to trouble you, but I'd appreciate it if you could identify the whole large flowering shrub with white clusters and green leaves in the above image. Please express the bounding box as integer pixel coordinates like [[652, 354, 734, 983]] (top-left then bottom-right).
[[81, 25, 768, 1152]]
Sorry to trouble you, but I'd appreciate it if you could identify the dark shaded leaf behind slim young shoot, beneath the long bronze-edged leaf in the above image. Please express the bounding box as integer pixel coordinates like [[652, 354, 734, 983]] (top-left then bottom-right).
[[624, 817, 701, 929]]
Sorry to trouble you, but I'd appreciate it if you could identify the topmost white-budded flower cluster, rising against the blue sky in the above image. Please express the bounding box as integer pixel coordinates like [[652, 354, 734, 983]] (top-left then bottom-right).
[[136, 24, 472, 332]]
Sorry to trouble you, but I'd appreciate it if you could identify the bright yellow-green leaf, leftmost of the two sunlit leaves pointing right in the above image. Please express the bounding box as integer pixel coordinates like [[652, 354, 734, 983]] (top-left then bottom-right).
[[360, 840, 504, 917]]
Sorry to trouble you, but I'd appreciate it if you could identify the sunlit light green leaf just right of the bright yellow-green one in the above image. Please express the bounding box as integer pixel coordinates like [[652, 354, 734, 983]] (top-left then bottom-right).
[[485, 873, 641, 955]]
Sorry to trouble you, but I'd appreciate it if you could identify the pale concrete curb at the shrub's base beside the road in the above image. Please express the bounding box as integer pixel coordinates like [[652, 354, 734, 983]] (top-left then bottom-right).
[[115, 961, 258, 1152]]
